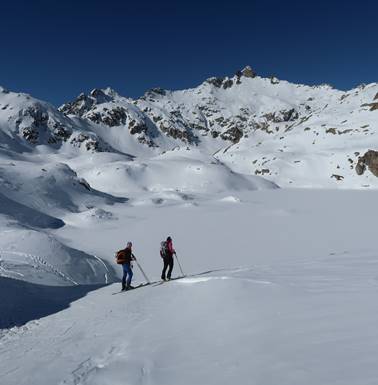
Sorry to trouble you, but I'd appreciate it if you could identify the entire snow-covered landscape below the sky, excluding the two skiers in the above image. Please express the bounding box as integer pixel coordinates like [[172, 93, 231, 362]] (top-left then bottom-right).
[[0, 67, 378, 385]]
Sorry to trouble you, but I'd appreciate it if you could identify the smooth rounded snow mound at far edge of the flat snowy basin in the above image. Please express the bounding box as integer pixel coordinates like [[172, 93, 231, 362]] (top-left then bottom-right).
[[69, 149, 277, 195]]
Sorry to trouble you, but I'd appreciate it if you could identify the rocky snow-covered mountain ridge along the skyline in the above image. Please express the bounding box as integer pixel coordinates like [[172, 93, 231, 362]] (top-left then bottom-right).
[[0, 67, 378, 188]]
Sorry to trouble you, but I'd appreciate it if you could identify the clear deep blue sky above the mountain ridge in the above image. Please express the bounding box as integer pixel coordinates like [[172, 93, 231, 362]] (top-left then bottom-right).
[[0, 0, 378, 105]]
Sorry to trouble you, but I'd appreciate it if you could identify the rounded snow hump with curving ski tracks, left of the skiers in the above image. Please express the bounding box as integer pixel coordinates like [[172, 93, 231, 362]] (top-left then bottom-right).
[[0, 226, 114, 286]]
